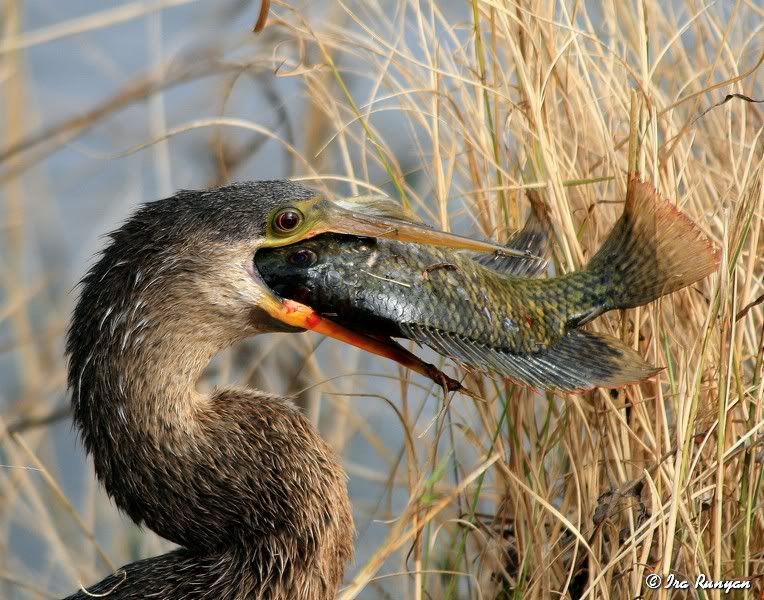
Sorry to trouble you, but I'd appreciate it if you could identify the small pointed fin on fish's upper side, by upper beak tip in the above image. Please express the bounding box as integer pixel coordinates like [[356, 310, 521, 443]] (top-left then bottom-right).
[[474, 190, 549, 277]]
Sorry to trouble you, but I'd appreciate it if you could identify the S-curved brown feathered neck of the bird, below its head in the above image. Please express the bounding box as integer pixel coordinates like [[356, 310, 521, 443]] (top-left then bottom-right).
[[69, 271, 353, 598]]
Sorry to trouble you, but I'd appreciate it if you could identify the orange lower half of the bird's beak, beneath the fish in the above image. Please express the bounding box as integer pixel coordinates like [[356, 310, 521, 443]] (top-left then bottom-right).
[[260, 288, 462, 391]]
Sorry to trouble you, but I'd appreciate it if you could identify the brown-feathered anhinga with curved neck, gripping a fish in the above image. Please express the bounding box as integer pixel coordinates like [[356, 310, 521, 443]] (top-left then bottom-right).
[[62, 181, 510, 600]]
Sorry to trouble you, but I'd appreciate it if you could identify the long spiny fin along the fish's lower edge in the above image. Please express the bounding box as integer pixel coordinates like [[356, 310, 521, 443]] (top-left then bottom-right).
[[402, 324, 660, 392]]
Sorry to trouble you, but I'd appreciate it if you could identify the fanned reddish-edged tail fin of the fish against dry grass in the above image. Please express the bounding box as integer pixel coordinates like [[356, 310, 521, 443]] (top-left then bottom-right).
[[586, 177, 719, 310]]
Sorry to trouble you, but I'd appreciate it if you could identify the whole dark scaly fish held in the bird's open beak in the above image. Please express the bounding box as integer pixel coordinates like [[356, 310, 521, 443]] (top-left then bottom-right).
[[254, 177, 719, 393]]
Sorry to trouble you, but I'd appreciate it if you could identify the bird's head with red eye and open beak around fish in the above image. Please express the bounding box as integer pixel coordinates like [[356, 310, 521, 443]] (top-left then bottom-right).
[[75, 181, 506, 384]]
